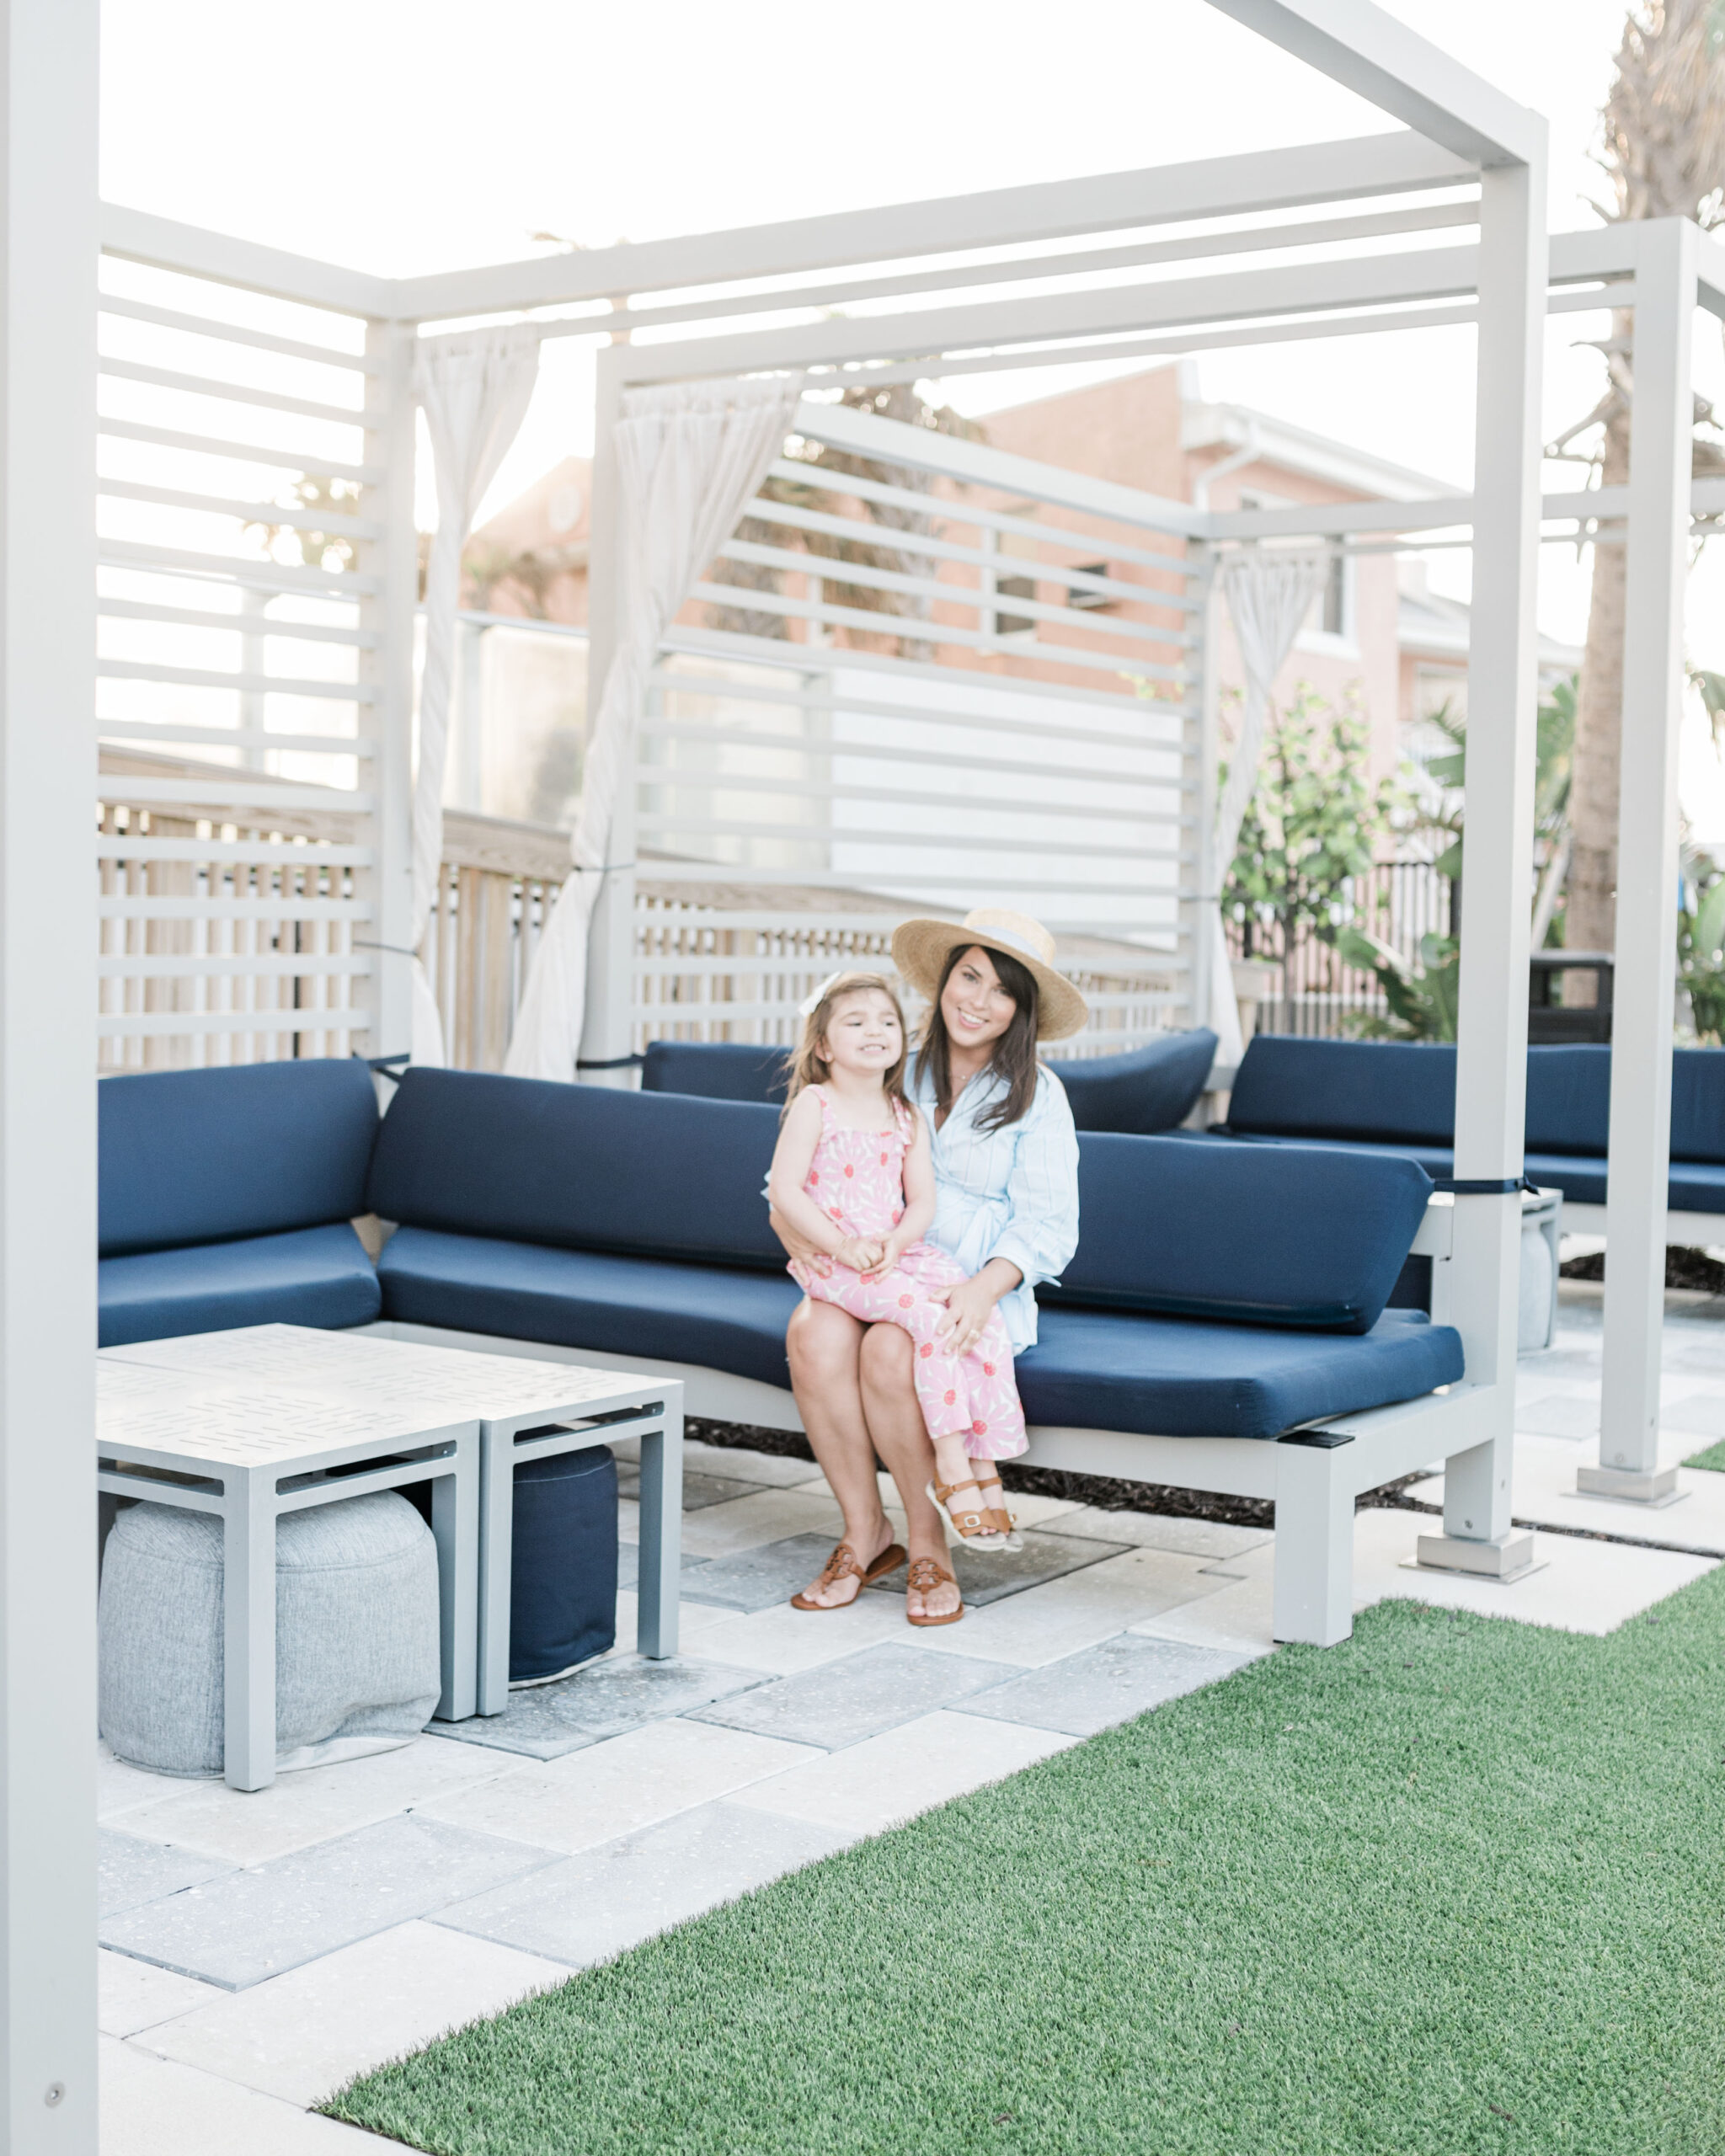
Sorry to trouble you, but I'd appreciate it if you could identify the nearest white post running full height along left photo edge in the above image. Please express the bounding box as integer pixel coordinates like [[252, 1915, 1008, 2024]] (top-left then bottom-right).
[[0, 0, 99, 2156]]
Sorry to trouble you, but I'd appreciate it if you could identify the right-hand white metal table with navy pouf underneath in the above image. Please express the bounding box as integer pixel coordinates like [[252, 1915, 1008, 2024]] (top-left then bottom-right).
[[105, 1326, 684, 1714]]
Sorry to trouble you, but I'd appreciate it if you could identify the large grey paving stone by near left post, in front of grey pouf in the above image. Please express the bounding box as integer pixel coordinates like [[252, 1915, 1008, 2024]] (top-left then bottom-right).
[[101, 1816, 552, 1992]]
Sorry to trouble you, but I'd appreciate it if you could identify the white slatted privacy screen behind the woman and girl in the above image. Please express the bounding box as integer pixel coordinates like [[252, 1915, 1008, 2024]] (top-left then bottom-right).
[[634, 408, 1210, 1052]]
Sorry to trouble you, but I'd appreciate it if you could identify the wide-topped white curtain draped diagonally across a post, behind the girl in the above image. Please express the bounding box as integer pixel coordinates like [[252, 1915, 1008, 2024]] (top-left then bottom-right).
[[505, 375, 802, 1081]]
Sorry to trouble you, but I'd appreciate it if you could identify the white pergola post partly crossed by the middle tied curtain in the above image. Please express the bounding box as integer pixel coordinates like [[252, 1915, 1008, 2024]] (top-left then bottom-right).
[[576, 364, 636, 1086]]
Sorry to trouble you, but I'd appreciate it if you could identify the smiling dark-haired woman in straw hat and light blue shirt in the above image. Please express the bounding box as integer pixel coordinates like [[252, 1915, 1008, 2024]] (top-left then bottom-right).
[[772, 908, 1087, 1617]]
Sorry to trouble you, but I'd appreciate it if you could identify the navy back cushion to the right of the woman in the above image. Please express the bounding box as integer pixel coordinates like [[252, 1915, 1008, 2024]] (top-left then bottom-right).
[[1052, 1132, 1432, 1332]]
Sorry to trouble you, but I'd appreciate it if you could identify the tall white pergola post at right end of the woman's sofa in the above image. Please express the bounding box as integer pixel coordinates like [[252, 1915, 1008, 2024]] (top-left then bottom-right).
[[1418, 147, 1546, 1578]]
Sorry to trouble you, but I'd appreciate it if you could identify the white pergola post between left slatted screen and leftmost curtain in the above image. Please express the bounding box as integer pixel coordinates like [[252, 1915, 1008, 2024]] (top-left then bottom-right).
[[360, 321, 419, 1056]]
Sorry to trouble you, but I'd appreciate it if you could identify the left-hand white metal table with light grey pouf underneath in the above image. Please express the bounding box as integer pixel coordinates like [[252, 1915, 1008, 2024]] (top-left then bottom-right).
[[97, 1350, 481, 1790]]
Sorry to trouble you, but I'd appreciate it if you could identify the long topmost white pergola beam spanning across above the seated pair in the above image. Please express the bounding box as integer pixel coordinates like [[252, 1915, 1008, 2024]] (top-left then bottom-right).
[[393, 131, 1472, 321]]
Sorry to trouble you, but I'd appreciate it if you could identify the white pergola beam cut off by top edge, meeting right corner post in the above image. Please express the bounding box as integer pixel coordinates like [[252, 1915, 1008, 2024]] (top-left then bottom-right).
[[1210, 0, 1546, 166]]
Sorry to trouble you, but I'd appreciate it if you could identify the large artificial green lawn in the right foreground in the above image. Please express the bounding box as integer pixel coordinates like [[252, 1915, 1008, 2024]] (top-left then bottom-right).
[[328, 1570, 1725, 2156]]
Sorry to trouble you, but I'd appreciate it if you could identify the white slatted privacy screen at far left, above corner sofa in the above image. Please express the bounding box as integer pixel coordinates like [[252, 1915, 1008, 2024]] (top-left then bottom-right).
[[97, 257, 384, 1070]]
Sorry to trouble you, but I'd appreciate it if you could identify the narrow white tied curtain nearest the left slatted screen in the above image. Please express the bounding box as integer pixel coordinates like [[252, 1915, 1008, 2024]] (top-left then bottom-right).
[[412, 328, 539, 1063]]
